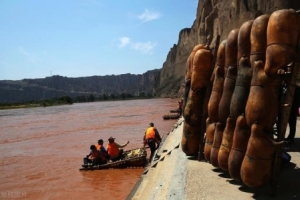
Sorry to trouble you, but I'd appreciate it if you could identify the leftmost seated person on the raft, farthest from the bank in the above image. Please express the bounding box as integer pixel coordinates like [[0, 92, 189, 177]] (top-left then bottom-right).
[[82, 145, 107, 167]]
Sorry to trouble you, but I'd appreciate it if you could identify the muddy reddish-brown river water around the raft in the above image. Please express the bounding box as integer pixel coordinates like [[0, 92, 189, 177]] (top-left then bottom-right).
[[0, 98, 177, 199]]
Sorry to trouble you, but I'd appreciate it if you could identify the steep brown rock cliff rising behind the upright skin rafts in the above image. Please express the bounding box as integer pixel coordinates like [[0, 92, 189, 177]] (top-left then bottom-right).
[[157, 0, 300, 97]]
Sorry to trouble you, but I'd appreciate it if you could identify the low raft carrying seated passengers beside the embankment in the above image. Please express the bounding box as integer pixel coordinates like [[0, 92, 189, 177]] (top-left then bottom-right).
[[79, 148, 147, 170]]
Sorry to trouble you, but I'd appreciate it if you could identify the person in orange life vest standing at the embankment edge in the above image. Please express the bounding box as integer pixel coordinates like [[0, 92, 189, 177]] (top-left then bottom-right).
[[144, 122, 161, 161]]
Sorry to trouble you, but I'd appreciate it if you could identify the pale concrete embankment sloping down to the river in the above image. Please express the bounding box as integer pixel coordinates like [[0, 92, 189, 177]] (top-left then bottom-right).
[[127, 118, 300, 200]]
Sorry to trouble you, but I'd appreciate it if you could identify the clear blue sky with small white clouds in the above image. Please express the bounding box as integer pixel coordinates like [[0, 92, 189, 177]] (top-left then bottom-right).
[[0, 0, 198, 80]]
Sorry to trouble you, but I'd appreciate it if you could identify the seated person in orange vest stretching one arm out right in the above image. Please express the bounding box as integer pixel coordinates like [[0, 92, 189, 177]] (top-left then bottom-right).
[[106, 137, 129, 162]]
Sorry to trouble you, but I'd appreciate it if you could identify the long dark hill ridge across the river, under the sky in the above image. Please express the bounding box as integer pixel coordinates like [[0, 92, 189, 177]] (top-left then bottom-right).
[[0, 70, 160, 103]]
